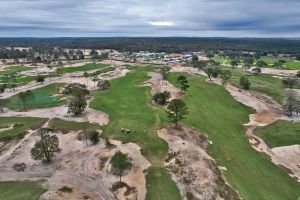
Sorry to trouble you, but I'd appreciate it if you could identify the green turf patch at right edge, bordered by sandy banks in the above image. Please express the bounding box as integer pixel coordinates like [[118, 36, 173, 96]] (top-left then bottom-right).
[[254, 120, 300, 148]]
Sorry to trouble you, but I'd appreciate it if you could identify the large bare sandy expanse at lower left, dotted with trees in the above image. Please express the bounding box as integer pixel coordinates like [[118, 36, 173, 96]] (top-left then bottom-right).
[[0, 126, 150, 200]]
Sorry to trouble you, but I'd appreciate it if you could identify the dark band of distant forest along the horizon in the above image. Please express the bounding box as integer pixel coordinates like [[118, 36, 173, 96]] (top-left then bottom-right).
[[0, 38, 300, 54]]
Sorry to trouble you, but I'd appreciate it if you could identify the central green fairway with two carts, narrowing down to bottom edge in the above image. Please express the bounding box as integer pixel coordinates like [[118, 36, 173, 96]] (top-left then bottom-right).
[[90, 67, 180, 200]]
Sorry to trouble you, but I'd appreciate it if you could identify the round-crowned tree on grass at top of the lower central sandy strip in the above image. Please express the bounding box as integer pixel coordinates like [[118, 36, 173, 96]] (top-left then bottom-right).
[[166, 99, 188, 128]]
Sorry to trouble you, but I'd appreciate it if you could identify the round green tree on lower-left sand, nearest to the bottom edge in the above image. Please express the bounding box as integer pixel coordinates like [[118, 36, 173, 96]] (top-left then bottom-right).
[[110, 151, 132, 182]]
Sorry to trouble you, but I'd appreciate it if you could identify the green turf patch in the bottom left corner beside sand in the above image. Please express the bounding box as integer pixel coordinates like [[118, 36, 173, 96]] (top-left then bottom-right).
[[0, 181, 46, 200]]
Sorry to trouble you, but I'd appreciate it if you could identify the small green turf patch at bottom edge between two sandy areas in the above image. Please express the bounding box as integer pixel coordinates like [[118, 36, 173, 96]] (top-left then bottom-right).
[[146, 168, 181, 200]]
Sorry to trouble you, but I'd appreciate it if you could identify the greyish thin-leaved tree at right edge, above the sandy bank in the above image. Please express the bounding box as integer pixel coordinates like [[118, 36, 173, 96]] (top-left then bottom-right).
[[283, 90, 300, 117]]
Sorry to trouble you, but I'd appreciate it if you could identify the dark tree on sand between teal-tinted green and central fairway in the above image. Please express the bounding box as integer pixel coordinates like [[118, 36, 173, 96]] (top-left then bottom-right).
[[67, 88, 87, 117]]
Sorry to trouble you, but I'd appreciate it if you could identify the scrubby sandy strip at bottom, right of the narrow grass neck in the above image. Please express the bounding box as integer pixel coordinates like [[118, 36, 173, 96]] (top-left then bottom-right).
[[157, 127, 240, 200]]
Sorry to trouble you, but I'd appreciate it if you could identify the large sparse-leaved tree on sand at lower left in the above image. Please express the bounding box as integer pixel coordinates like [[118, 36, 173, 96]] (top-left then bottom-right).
[[31, 128, 61, 162]]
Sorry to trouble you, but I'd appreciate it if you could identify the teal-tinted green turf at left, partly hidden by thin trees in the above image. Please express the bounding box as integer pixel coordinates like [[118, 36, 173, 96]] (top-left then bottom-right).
[[6, 83, 65, 109]]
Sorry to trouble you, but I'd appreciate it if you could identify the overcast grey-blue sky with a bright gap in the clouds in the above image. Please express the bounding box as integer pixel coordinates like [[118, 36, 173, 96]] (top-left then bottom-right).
[[0, 0, 300, 37]]
